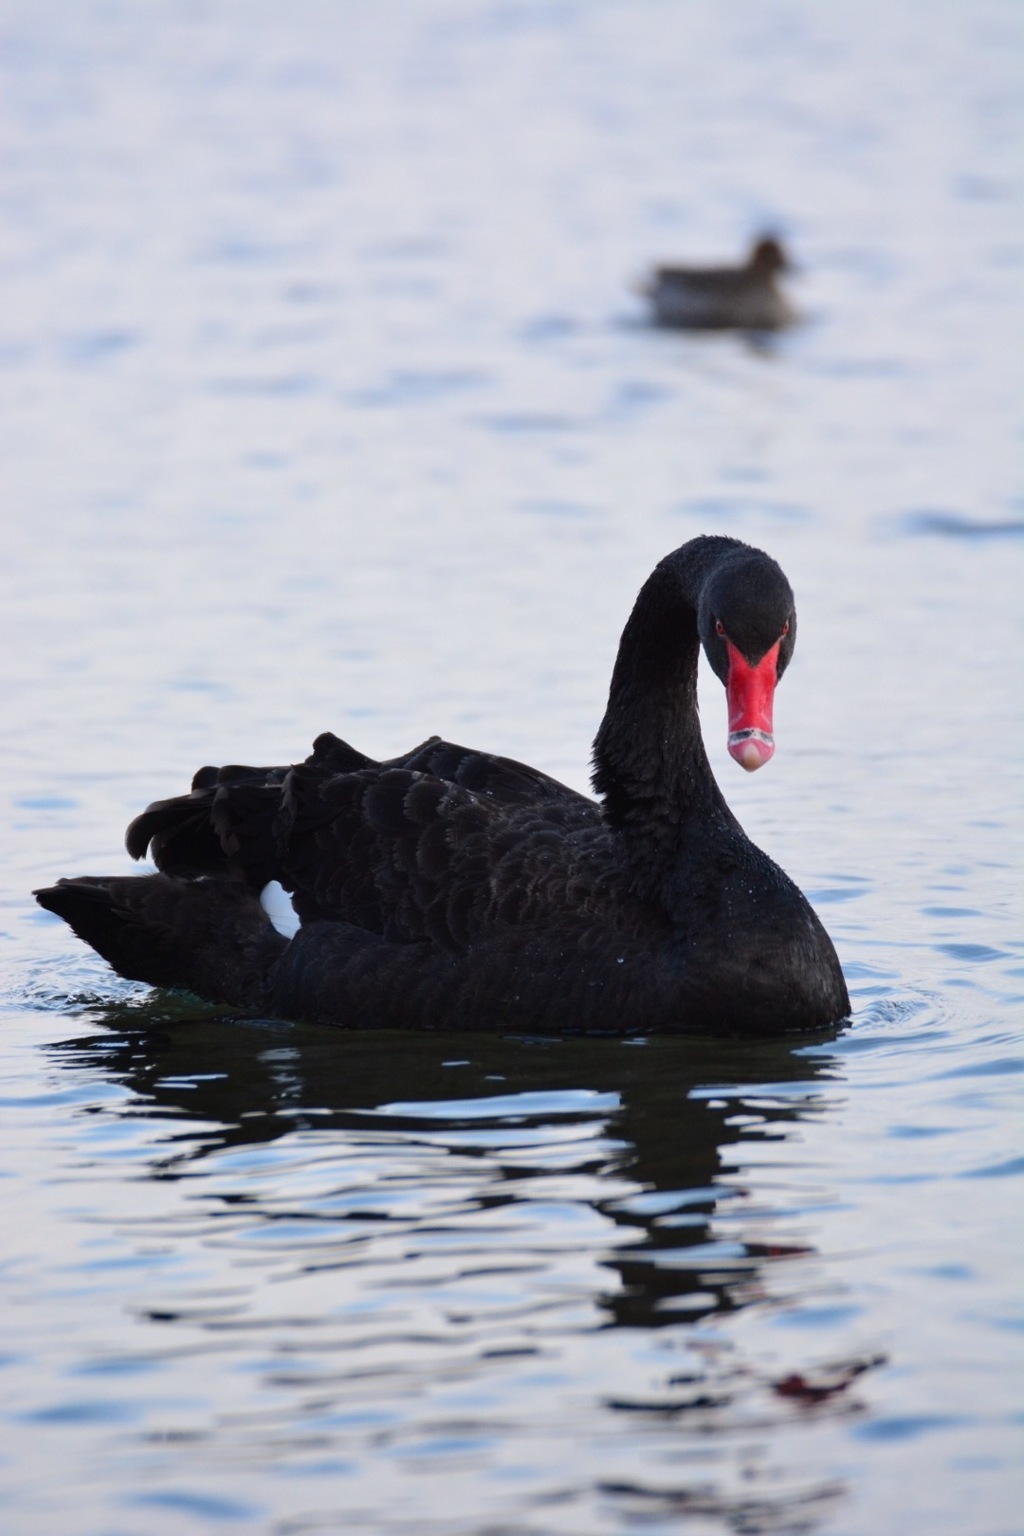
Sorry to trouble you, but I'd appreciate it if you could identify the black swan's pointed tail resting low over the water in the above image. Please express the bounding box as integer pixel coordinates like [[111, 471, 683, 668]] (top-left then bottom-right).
[[34, 874, 287, 1009]]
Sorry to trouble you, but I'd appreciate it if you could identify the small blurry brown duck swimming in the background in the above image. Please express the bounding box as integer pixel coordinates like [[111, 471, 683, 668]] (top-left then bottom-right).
[[640, 235, 797, 330]]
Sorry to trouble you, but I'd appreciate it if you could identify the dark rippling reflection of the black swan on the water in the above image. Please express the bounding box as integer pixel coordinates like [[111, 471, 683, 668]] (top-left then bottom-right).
[[46, 1005, 829, 1329]]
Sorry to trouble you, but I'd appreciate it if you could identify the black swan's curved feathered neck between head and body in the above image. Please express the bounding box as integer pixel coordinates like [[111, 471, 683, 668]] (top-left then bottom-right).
[[593, 556, 735, 872]]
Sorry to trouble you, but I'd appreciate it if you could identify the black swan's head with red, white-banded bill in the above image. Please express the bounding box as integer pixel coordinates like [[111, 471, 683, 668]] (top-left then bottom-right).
[[697, 548, 797, 773]]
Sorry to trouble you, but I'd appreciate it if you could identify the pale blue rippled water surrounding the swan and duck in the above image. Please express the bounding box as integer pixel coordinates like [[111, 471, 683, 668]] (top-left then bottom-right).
[[0, 0, 1024, 1536]]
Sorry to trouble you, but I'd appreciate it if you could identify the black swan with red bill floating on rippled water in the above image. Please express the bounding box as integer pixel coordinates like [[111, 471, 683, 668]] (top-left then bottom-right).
[[35, 536, 849, 1035]]
